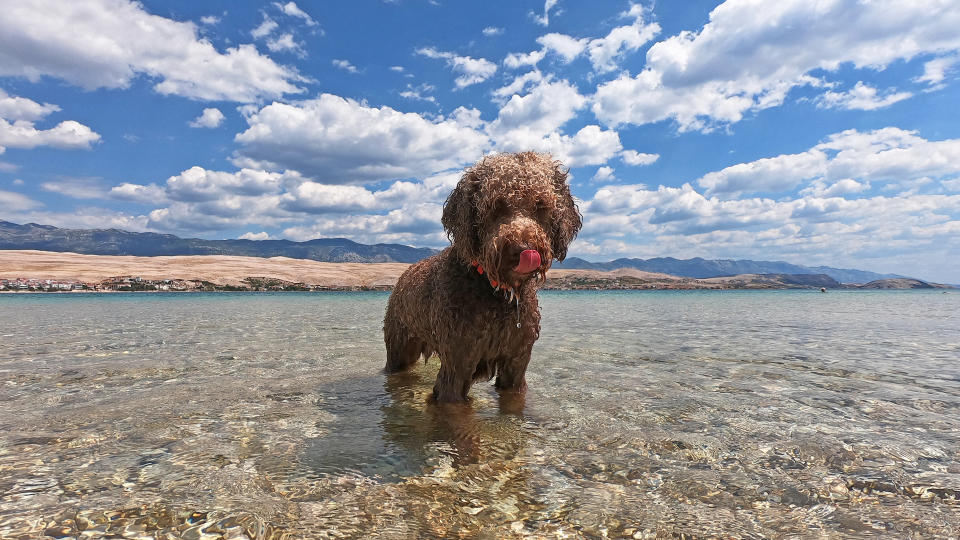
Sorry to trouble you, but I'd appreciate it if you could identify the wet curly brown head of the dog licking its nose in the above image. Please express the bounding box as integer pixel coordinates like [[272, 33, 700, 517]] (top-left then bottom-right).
[[442, 152, 582, 287]]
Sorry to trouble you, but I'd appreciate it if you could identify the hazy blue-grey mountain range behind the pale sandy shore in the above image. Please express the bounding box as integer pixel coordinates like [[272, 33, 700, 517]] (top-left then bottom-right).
[[0, 221, 905, 283]]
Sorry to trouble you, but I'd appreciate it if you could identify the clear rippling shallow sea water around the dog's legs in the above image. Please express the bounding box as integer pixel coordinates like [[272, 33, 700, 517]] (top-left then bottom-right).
[[0, 291, 960, 538]]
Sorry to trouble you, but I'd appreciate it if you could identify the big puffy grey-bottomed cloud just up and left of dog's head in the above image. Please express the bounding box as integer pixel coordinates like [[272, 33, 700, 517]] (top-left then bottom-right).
[[236, 94, 489, 184]]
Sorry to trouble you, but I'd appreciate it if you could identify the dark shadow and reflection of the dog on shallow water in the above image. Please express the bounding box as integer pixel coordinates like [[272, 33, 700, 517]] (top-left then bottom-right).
[[302, 368, 526, 481]]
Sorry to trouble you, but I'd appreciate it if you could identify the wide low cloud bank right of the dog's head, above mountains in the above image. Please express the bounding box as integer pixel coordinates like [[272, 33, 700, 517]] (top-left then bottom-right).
[[577, 128, 960, 279]]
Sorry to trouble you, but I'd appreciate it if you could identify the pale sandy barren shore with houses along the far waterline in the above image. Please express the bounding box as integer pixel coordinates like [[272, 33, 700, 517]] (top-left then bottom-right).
[[0, 250, 952, 293]]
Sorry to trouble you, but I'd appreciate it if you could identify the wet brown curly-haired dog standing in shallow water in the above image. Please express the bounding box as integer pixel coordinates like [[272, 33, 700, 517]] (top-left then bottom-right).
[[383, 152, 581, 402]]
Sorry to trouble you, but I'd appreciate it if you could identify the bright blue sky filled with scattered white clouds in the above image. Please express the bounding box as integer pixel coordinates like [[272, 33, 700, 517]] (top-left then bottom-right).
[[0, 0, 960, 283]]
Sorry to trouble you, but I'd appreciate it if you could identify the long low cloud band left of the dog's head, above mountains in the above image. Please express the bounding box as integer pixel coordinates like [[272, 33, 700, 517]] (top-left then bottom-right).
[[118, 167, 461, 240]]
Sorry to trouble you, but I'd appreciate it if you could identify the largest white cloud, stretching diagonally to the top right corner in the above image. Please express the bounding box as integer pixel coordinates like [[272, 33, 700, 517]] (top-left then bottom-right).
[[593, 0, 960, 131]]
